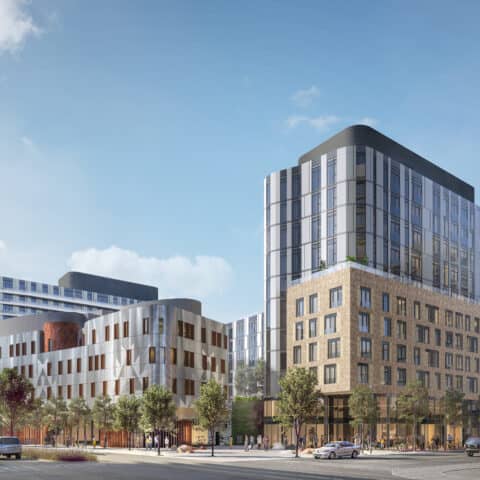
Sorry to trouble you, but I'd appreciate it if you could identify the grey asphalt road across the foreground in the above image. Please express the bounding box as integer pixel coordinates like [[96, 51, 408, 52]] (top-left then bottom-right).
[[0, 454, 480, 480]]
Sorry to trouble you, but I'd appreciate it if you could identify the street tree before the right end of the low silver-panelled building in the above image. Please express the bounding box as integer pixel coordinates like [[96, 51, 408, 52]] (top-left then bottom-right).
[[195, 378, 228, 457]]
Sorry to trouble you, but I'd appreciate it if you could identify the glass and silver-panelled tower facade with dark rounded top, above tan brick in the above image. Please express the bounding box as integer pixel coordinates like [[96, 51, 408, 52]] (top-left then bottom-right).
[[264, 126, 480, 396]]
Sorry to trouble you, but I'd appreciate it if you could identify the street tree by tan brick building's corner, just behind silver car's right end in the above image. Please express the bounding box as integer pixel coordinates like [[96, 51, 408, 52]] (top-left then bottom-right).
[[348, 385, 377, 450]]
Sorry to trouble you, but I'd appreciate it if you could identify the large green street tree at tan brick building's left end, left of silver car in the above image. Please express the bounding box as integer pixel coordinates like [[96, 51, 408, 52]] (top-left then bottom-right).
[[278, 368, 321, 457]]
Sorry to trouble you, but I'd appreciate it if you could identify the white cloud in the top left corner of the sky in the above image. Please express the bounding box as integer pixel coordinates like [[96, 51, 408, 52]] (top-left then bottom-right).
[[0, 0, 41, 53]]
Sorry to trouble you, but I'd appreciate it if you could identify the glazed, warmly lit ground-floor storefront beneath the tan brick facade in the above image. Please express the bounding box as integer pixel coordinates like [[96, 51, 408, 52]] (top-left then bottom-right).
[[264, 395, 480, 449]]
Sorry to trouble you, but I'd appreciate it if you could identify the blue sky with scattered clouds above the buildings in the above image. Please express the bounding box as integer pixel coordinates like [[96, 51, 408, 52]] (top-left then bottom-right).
[[0, 0, 480, 322]]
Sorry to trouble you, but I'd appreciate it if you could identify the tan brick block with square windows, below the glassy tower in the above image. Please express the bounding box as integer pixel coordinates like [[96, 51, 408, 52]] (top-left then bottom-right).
[[265, 262, 480, 446]]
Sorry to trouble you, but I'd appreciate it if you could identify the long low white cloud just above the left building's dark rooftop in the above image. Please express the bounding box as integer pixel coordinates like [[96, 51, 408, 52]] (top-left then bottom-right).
[[67, 245, 233, 299]]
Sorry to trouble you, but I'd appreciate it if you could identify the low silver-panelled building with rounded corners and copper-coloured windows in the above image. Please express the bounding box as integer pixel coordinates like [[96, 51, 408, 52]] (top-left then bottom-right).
[[0, 299, 228, 443]]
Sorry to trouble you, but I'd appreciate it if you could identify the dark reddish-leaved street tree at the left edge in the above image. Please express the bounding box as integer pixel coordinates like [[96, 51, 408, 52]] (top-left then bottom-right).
[[0, 368, 34, 435]]
